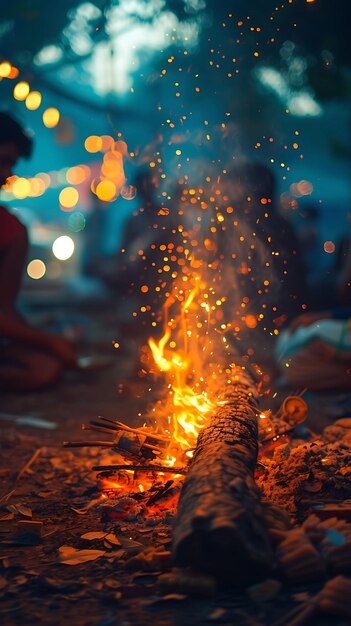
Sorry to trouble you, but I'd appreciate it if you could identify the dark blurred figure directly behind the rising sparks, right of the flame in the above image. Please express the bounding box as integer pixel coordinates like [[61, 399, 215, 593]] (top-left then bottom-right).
[[226, 161, 306, 335]]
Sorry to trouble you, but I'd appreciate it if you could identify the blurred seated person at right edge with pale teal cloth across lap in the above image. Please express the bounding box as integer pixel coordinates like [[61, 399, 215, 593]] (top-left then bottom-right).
[[276, 207, 351, 392]]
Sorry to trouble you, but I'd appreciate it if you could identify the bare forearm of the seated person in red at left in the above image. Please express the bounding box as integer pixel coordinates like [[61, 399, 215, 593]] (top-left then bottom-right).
[[0, 311, 77, 367]]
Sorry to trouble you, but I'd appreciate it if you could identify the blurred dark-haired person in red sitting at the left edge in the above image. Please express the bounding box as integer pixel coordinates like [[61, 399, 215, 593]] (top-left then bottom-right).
[[0, 112, 77, 390]]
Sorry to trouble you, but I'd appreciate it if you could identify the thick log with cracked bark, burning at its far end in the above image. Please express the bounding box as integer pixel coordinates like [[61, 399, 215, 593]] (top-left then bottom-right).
[[173, 367, 272, 582]]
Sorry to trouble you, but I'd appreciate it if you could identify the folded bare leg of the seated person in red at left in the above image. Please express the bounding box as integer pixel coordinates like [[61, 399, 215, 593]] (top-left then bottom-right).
[[0, 346, 62, 391]]
